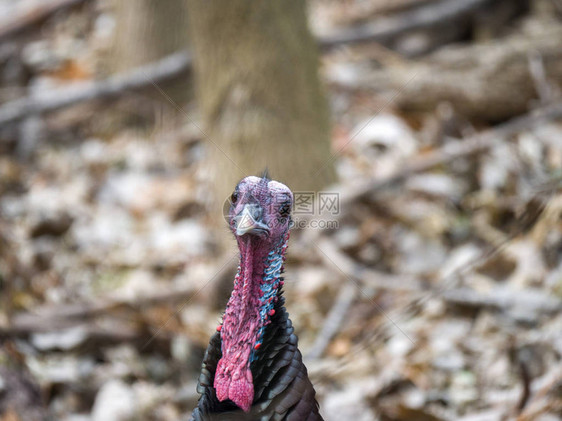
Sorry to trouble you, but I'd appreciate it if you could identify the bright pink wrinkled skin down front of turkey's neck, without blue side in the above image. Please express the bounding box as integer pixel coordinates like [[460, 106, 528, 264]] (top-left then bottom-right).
[[214, 236, 276, 412]]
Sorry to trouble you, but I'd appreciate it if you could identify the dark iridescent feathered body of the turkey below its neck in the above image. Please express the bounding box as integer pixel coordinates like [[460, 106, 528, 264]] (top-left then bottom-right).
[[191, 293, 323, 421]]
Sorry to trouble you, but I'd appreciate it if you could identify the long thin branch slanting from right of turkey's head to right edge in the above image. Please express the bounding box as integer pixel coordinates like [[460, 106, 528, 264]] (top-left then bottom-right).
[[339, 102, 562, 212]]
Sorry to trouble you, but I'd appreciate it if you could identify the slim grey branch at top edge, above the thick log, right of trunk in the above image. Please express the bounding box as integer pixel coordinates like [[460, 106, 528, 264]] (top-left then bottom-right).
[[318, 0, 490, 49]]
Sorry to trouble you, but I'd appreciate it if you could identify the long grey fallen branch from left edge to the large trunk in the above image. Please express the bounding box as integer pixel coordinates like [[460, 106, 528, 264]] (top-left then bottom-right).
[[0, 52, 191, 126]]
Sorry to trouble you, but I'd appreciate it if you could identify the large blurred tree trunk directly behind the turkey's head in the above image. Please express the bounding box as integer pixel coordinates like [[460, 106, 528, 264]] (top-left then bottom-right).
[[187, 0, 335, 208]]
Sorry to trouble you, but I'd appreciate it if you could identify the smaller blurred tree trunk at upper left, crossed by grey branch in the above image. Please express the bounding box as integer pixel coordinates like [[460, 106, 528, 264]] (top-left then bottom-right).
[[109, 0, 189, 102]]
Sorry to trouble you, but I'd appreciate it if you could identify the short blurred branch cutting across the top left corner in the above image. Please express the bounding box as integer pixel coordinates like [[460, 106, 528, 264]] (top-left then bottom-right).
[[0, 0, 86, 41]]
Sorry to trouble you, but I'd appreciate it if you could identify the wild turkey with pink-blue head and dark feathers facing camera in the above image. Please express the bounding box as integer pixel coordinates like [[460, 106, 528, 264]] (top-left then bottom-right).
[[192, 176, 322, 421]]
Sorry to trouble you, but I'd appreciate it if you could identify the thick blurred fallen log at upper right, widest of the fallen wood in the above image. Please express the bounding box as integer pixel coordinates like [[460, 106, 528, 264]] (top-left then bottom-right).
[[326, 20, 562, 122]]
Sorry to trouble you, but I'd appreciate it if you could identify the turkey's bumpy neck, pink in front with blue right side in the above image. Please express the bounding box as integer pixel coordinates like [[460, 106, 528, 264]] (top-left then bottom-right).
[[215, 233, 289, 411]]
